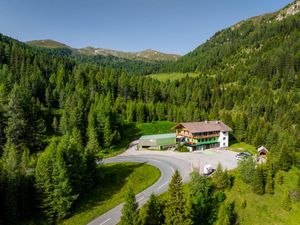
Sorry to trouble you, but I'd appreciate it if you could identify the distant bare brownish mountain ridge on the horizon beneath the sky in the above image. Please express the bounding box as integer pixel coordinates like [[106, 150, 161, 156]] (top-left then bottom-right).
[[26, 39, 180, 61]]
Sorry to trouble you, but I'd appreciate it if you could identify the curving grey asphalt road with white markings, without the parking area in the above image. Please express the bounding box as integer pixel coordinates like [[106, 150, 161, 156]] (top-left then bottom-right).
[[88, 155, 190, 225]]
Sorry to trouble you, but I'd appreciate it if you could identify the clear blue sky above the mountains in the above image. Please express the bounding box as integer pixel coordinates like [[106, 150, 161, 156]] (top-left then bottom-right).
[[0, 0, 292, 54]]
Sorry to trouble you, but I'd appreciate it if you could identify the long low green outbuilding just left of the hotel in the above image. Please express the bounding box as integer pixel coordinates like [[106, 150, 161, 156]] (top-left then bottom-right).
[[138, 133, 176, 150]]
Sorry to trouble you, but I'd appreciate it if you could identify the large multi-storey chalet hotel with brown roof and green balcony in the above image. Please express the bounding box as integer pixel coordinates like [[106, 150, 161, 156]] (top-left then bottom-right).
[[175, 120, 232, 151]]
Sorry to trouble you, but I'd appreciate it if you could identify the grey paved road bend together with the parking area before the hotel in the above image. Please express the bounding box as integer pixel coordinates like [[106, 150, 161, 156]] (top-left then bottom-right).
[[88, 141, 237, 225]]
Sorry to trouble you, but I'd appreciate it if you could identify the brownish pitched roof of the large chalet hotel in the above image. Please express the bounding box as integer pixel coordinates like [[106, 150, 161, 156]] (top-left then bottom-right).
[[176, 120, 232, 133]]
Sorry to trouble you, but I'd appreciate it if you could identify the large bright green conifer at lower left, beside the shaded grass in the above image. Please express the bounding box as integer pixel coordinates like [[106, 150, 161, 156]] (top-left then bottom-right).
[[35, 138, 78, 223]]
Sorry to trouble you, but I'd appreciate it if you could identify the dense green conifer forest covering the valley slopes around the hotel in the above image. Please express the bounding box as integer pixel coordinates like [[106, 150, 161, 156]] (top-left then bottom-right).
[[0, 0, 300, 224]]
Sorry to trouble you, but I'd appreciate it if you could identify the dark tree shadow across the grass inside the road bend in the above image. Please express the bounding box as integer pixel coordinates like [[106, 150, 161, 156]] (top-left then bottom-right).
[[70, 163, 144, 217]]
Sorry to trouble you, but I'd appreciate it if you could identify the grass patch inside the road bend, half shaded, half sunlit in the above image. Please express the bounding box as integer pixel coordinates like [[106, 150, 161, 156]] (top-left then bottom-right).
[[59, 163, 160, 225]]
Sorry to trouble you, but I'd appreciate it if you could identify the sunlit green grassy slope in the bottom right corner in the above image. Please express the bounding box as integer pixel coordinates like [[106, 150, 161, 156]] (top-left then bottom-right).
[[227, 168, 300, 225]]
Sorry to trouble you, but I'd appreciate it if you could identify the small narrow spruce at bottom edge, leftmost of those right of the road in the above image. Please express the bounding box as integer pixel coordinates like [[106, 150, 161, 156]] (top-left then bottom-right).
[[120, 186, 139, 225]]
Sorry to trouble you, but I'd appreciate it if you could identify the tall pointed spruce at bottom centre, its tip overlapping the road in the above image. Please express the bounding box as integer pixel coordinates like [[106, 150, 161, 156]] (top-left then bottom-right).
[[164, 170, 192, 225]]
